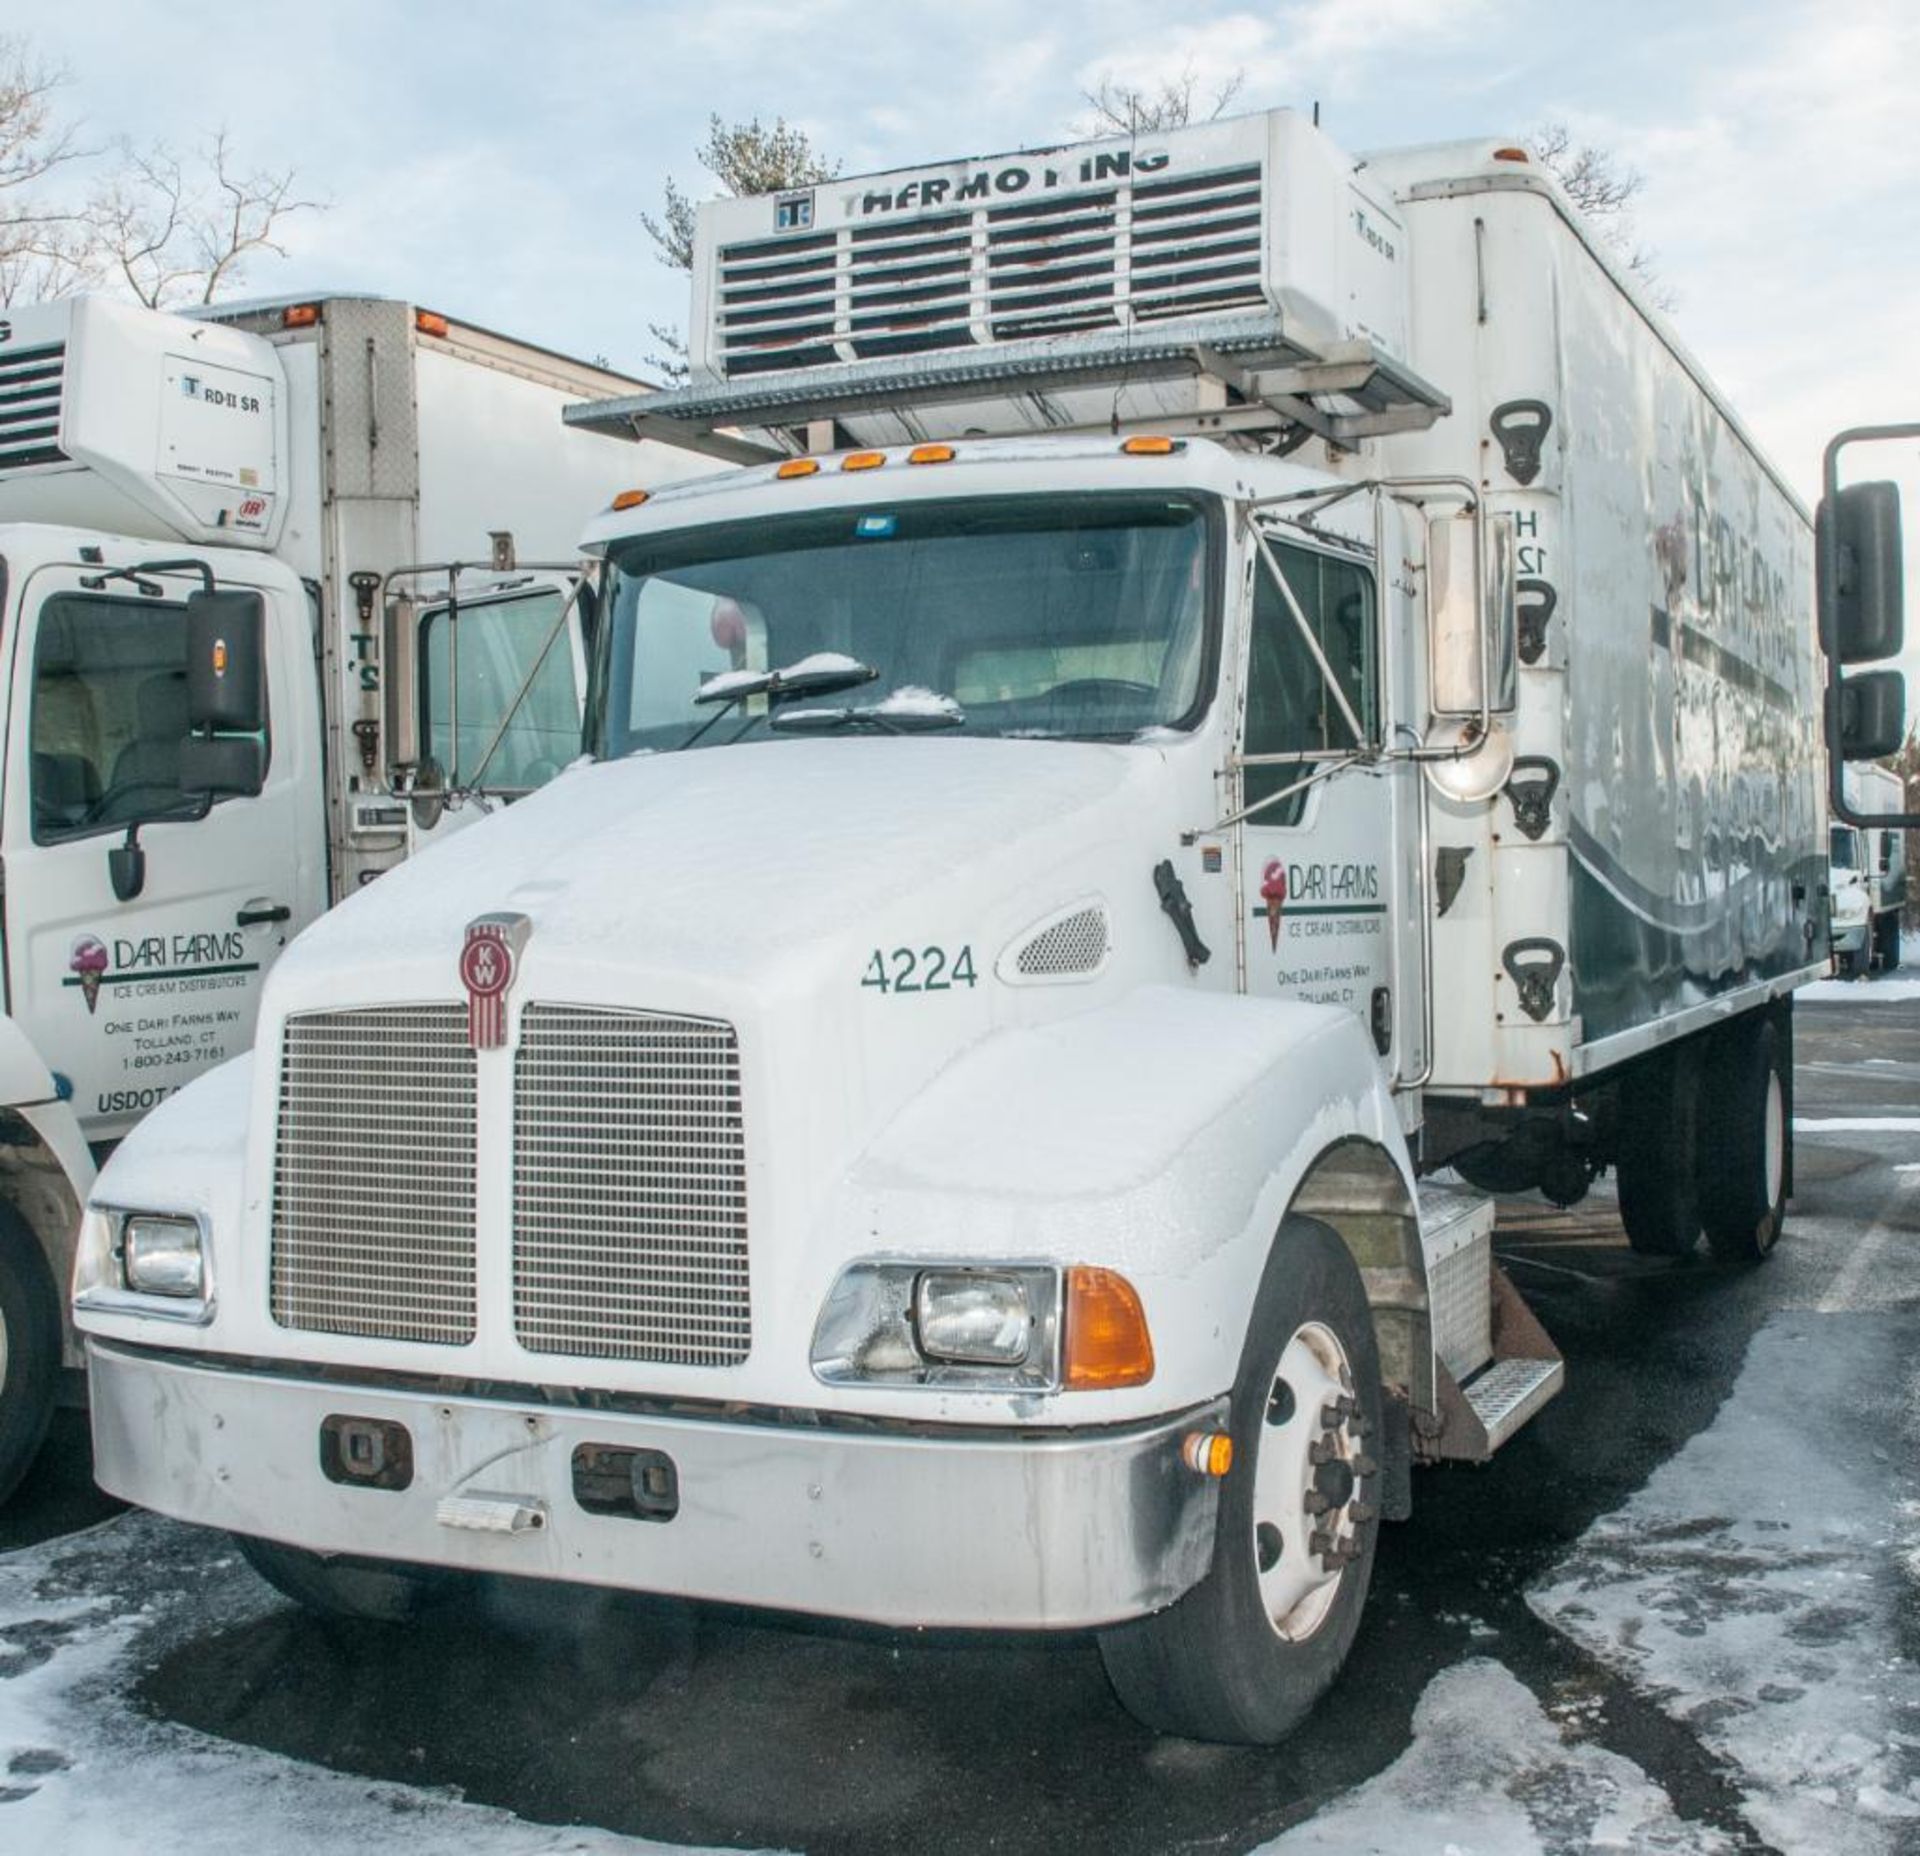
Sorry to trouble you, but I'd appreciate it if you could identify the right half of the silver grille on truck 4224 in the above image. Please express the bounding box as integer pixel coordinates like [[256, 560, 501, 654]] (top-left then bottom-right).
[[513, 1004, 751, 1367]]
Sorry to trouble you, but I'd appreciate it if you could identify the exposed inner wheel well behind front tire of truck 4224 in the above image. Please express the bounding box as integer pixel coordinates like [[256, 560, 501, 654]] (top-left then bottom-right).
[[1286, 1138, 1434, 1411]]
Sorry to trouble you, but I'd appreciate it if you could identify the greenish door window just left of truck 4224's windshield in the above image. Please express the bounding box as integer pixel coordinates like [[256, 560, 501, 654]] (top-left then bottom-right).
[[420, 587, 580, 793]]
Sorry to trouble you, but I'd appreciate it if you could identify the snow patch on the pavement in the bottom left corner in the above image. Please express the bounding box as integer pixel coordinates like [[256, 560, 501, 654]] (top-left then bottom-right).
[[0, 1514, 764, 1856]]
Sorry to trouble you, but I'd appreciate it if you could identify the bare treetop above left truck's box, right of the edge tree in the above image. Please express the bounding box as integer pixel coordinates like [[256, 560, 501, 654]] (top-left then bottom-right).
[[86, 129, 323, 309]]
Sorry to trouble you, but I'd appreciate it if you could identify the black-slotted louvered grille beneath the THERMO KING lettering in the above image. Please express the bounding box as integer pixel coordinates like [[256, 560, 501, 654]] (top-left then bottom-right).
[[714, 163, 1265, 378]]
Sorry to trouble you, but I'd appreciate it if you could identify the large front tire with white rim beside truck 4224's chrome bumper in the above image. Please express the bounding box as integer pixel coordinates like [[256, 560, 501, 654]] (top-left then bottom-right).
[[1100, 1217, 1380, 1747]]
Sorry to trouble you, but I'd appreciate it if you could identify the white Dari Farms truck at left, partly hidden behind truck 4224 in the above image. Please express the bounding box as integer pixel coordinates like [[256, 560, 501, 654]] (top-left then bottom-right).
[[0, 297, 702, 1497]]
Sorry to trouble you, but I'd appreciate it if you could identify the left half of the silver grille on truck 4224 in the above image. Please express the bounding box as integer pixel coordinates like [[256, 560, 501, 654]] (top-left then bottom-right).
[[271, 1006, 474, 1347]]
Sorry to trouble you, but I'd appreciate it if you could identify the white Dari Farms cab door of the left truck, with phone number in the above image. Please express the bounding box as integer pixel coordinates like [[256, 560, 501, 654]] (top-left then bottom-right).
[[0, 564, 324, 1140]]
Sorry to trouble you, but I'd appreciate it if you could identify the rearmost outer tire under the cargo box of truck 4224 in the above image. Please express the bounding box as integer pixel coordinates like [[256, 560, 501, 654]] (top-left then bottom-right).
[[1699, 1011, 1793, 1263]]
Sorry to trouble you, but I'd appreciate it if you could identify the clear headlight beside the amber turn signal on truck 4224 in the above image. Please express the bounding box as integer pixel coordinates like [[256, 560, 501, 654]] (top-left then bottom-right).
[[812, 1261, 1060, 1392]]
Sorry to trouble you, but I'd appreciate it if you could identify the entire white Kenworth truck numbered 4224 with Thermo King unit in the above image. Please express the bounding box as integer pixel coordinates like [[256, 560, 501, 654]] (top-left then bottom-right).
[[75, 111, 1826, 1741]]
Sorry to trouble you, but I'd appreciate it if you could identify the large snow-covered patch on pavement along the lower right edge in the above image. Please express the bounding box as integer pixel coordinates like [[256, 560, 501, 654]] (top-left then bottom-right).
[[1530, 1313, 1920, 1856]]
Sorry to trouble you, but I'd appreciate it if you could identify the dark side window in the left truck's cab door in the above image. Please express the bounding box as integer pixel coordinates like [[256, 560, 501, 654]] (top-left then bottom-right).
[[29, 593, 208, 845]]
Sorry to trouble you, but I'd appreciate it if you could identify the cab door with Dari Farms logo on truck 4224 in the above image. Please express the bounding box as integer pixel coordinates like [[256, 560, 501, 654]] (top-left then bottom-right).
[[1236, 526, 1425, 1073]]
